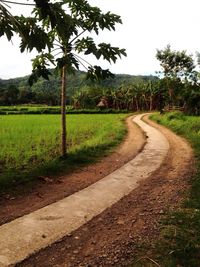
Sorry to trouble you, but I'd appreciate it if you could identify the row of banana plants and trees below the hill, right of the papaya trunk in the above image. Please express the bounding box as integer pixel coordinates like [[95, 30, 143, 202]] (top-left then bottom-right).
[[72, 78, 200, 115]]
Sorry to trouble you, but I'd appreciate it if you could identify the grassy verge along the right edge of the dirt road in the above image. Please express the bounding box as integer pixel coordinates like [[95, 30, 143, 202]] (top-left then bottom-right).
[[132, 112, 200, 267]]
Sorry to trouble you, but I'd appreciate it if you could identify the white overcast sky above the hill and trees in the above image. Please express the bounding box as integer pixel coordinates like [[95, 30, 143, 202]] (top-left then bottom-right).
[[0, 0, 200, 78]]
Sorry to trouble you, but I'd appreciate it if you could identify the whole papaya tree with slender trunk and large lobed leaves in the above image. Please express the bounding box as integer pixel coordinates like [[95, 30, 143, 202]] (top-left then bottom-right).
[[0, 0, 126, 156]]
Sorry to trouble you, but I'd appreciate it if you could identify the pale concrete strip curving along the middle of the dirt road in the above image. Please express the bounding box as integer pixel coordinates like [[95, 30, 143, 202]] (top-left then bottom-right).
[[0, 115, 169, 266]]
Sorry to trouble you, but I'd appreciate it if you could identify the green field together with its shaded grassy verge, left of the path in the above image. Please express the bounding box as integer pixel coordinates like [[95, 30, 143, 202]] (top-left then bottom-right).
[[0, 114, 127, 192]]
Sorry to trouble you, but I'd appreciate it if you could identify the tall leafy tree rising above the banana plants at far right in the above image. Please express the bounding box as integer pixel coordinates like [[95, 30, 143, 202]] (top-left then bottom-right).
[[156, 45, 200, 115]]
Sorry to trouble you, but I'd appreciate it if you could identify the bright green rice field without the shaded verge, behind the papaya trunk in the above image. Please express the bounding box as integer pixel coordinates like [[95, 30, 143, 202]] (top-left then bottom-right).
[[0, 114, 127, 178]]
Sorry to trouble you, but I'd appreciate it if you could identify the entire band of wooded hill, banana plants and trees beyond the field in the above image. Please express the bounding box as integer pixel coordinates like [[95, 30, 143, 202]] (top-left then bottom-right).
[[0, 46, 200, 115]]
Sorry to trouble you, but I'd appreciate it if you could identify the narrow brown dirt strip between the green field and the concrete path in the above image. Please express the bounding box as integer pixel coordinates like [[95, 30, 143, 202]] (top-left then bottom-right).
[[0, 117, 145, 225]]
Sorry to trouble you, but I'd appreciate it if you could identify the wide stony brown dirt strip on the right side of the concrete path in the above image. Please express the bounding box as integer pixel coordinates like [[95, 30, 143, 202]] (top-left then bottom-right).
[[17, 115, 194, 267]]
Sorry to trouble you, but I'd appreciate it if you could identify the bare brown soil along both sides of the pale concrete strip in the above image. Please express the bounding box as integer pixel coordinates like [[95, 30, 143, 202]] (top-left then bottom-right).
[[0, 115, 194, 267]]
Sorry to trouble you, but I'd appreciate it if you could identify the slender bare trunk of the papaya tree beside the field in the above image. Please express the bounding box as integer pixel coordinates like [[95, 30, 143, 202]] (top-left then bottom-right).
[[61, 66, 67, 157]]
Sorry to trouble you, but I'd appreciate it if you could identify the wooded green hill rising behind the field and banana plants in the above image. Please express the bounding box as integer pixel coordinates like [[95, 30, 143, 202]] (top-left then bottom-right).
[[0, 71, 158, 105]]
